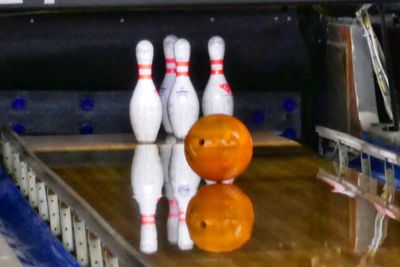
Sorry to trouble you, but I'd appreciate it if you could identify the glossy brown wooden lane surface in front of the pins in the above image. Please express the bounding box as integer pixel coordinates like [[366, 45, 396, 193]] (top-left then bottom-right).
[[34, 139, 400, 267]]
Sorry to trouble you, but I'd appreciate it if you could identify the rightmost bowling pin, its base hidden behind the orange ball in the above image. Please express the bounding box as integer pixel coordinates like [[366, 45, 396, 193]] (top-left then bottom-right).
[[202, 36, 233, 116]]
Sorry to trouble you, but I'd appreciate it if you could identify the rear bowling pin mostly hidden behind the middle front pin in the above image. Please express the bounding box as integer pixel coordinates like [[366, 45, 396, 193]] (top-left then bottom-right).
[[160, 35, 178, 134]]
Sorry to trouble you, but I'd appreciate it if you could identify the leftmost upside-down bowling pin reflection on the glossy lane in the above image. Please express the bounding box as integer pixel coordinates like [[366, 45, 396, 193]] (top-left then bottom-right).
[[131, 145, 163, 253]]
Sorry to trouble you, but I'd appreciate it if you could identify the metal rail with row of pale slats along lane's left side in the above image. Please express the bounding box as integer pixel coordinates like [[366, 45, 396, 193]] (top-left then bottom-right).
[[1, 126, 146, 267]]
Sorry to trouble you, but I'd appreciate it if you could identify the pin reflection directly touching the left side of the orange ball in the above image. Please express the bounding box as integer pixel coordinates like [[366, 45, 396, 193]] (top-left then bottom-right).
[[169, 143, 200, 250]]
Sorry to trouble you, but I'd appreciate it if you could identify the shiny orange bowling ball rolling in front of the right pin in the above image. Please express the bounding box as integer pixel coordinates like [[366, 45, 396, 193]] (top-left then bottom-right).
[[185, 114, 253, 181]]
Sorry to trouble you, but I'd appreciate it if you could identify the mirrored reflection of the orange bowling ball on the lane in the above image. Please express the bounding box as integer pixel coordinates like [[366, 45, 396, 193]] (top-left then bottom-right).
[[186, 184, 254, 252]]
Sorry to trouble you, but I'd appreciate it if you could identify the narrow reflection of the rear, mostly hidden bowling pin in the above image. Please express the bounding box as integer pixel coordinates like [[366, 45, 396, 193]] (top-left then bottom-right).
[[160, 135, 179, 244]]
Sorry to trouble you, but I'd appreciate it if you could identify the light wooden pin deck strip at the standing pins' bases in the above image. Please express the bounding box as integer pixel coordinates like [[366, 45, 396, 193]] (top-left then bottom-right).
[[22, 132, 299, 152]]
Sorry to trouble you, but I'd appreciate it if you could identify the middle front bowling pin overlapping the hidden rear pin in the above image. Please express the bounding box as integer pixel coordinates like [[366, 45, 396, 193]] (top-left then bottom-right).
[[168, 39, 199, 139]]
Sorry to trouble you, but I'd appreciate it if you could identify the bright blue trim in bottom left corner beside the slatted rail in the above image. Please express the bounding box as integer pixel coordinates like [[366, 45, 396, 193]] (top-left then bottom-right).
[[0, 167, 80, 267]]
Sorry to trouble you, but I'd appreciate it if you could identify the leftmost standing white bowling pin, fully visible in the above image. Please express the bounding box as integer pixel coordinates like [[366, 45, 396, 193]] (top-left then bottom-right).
[[129, 40, 162, 143]]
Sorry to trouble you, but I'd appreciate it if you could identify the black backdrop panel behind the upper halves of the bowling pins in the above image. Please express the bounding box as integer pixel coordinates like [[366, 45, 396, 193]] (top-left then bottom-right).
[[0, 6, 311, 91]]
